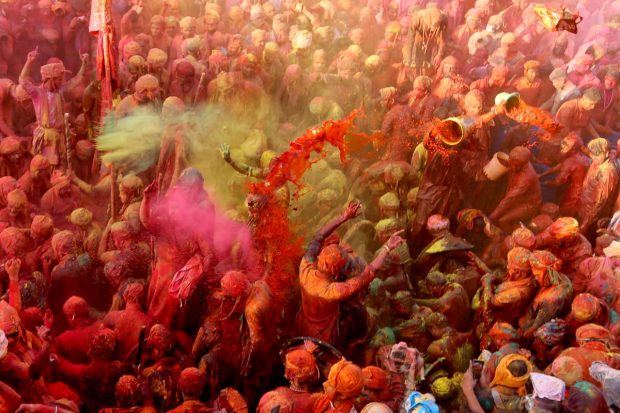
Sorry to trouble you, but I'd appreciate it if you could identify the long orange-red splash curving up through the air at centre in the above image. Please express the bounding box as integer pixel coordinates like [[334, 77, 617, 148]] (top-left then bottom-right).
[[250, 111, 358, 305]]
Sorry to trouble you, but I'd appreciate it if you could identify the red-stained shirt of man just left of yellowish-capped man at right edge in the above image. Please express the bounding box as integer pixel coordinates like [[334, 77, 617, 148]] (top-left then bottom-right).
[[554, 152, 589, 217]]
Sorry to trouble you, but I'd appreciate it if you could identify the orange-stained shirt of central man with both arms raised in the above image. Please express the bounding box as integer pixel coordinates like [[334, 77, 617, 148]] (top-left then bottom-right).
[[297, 253, 374, 343]]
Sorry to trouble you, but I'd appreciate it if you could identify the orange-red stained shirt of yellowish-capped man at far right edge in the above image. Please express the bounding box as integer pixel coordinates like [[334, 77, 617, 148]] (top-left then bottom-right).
[[580, 158, 618, 230]]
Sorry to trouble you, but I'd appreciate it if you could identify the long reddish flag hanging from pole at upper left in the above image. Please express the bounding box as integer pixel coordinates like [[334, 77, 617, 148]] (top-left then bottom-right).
[[89, 0, 119, 123]]
